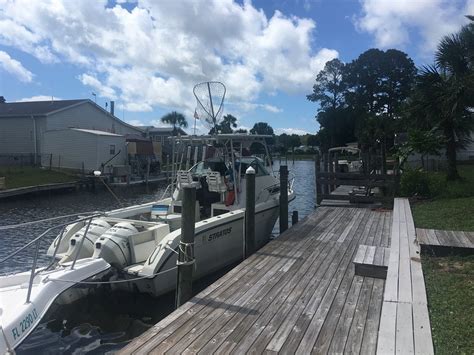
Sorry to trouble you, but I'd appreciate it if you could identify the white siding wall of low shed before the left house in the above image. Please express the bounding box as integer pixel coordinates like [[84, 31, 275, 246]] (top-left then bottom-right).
[[42, 129, 125, 171]]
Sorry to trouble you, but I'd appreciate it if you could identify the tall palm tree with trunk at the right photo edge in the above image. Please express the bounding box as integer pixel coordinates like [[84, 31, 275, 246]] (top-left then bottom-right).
[[412, 19, 474, 180]]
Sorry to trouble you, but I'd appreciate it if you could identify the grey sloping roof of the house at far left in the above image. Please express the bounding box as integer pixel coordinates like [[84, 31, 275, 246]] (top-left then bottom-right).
[[0, 99, 88, 117]]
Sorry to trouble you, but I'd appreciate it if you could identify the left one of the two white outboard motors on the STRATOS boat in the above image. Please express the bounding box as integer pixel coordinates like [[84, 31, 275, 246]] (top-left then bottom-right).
[[59, 218, 110, 264]]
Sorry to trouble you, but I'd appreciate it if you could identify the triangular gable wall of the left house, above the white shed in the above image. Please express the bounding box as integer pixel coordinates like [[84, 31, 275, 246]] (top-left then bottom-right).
[[47, 102, 141, 134]]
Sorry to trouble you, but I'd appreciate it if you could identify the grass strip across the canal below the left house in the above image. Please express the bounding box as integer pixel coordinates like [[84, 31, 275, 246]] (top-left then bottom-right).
[[0, 166, 77, 189]]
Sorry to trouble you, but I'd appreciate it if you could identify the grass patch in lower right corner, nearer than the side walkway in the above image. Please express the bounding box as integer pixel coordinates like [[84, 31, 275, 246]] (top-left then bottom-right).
[[422, 256, 474, 354]]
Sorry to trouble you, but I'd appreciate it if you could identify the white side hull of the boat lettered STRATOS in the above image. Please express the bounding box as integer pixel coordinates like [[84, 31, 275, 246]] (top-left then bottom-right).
[[120, 200, 279, 296]]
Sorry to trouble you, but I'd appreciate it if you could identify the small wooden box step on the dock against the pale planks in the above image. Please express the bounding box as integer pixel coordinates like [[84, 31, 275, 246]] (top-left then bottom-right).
[[353, 244, 390, 279]]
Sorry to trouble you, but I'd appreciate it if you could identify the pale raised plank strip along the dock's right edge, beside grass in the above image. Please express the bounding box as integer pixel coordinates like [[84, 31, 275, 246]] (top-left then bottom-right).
[[377, 198, 439, 354]]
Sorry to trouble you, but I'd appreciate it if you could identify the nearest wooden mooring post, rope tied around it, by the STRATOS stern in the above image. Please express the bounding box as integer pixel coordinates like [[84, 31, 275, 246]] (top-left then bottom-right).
[[176, 186, 196, 308]]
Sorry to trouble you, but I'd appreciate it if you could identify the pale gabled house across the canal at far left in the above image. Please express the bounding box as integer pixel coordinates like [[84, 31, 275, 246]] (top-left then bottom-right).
[[0, 100, 143, 169]]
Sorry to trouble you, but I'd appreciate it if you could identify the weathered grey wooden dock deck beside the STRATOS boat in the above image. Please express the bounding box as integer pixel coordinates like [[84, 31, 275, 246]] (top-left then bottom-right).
[[121, 207, 392, 354]]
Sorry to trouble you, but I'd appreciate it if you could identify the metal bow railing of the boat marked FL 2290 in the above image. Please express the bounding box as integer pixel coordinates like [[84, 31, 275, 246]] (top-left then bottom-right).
[[0, 213, 104, 303]]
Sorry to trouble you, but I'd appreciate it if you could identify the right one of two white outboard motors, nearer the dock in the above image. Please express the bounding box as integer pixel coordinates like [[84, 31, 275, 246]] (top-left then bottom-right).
[[93, 222, 138, 269]]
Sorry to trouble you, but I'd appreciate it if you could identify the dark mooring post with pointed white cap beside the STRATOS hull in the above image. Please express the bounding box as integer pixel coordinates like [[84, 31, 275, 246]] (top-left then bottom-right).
[[245, 166, 255, 258]]
